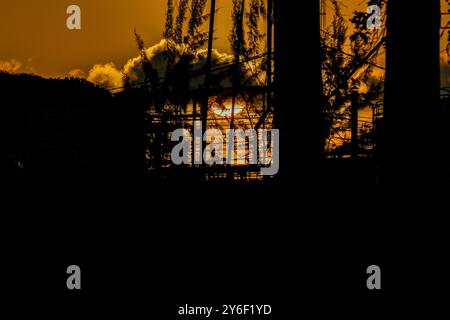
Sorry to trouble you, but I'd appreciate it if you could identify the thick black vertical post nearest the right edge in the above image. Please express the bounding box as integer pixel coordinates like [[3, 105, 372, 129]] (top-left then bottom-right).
[[379, 0, 442, 190]]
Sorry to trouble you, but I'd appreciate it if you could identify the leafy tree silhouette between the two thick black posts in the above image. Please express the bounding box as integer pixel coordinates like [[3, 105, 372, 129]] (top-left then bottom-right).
[[322, 0, 386, 155]]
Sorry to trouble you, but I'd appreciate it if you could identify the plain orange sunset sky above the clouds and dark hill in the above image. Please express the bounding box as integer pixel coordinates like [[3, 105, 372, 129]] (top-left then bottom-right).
[[0, 0, 448, 82]]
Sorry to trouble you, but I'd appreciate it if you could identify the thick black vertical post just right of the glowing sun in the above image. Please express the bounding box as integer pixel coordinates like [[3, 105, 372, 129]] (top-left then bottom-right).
[[273, 0, 323, 182]]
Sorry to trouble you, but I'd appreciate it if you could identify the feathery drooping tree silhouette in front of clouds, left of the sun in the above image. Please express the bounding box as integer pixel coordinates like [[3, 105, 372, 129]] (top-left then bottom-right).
[[130, 0, 214, 170]]
